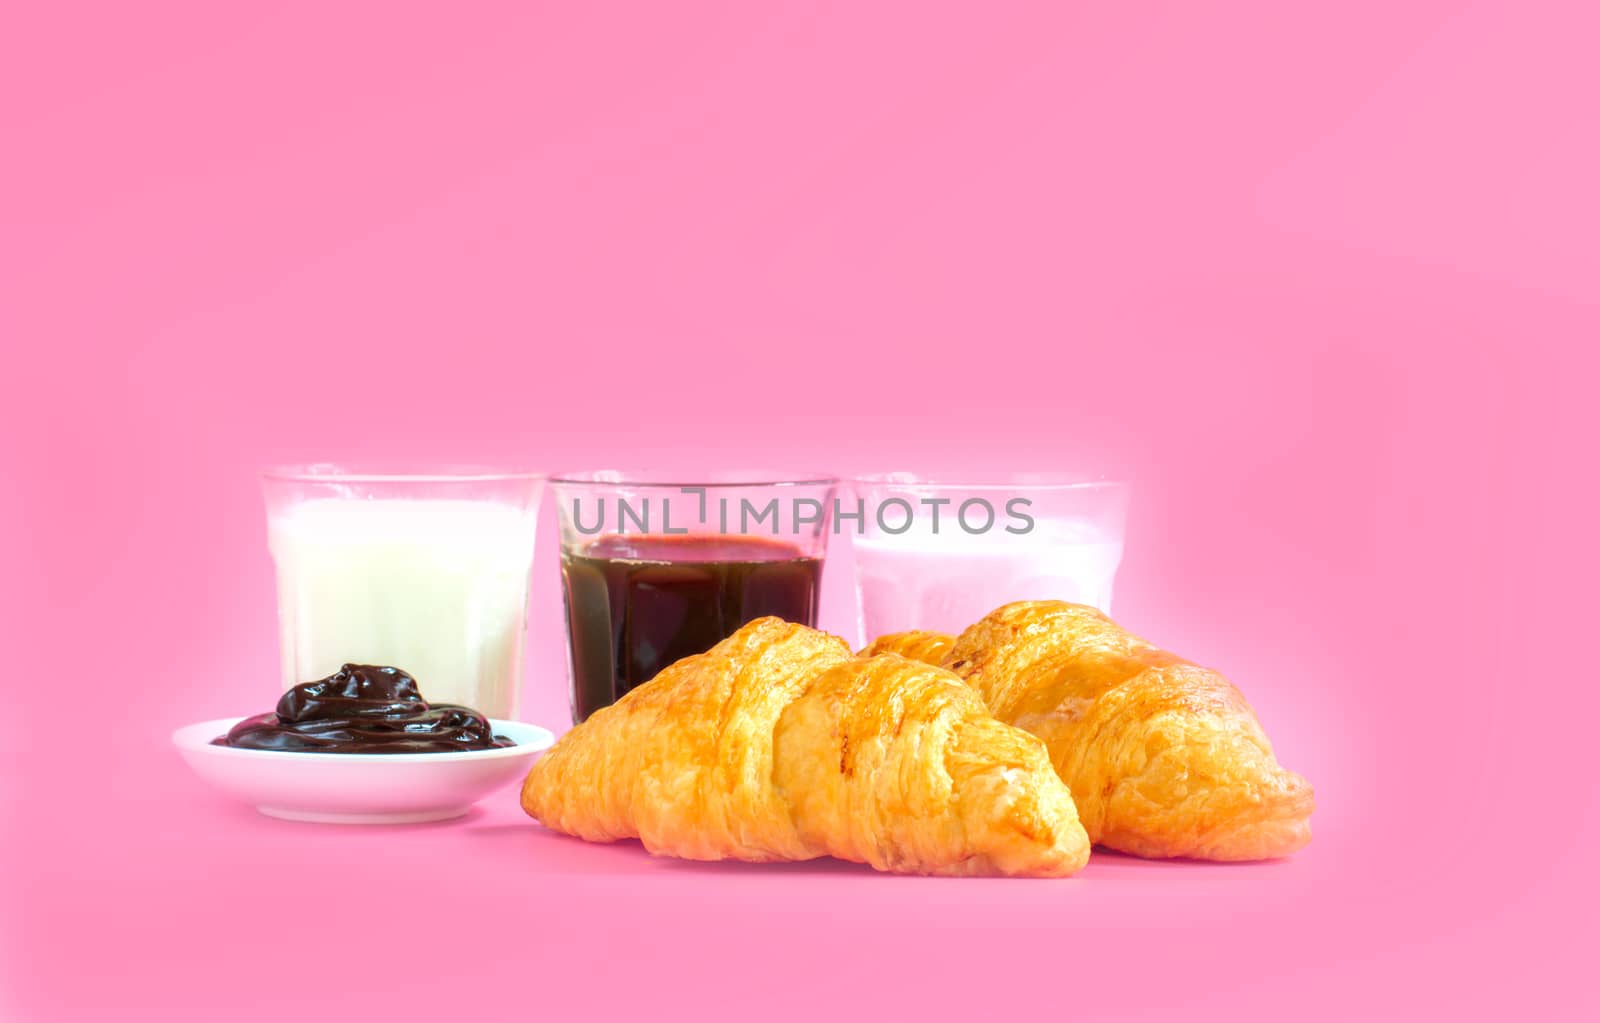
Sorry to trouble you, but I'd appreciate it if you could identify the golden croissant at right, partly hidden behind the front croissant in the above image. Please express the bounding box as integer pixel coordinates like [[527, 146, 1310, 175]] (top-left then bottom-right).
[[867, 600, 1314, 860]]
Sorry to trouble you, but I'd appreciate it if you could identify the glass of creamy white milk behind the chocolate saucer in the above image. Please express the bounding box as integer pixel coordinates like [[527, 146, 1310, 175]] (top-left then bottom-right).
[[261, 464, 544, 719]]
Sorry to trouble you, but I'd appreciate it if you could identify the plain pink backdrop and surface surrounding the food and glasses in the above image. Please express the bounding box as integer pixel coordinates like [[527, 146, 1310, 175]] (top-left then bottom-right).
[[0, 2, 1600, 1020]]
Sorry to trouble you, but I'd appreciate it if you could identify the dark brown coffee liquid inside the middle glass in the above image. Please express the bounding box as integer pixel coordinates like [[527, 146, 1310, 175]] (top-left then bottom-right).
[[562, 535, 822, 720]]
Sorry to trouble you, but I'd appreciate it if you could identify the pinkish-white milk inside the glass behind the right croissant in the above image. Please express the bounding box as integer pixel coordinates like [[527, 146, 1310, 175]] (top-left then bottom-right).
[[854, 522, 1122, 640]]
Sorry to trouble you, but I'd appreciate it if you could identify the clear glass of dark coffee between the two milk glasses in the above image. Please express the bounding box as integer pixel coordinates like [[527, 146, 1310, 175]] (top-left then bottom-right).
[[550, 469, 838, 722]]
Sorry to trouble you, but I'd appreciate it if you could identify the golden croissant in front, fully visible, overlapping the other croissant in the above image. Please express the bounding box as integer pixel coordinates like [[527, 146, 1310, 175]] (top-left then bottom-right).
[[522, 618, 1090, 877]]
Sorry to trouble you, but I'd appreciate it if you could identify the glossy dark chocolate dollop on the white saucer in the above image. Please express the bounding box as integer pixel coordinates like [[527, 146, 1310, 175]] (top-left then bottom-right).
[[211, 664, 515, 752]]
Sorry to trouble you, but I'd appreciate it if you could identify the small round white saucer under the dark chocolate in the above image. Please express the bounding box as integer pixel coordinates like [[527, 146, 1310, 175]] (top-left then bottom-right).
[[173, 717, 555, 824]]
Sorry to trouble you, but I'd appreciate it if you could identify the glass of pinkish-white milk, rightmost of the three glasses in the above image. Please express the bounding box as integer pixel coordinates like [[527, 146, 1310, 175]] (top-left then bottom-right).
[[835, 472, 1128, 642]]
